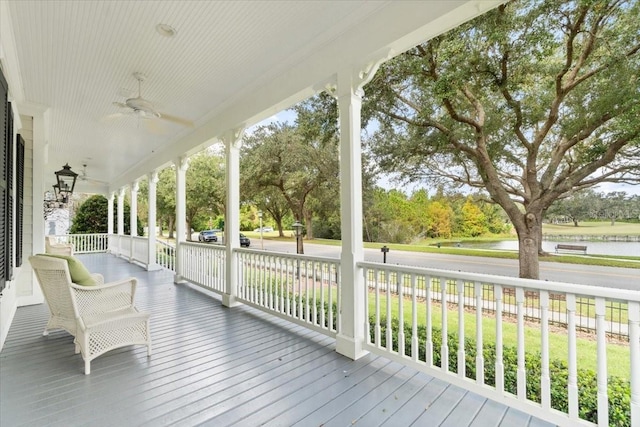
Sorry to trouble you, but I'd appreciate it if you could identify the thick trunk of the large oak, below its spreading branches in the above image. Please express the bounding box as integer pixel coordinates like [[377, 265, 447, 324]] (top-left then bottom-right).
[[514, 212, 542, 279]]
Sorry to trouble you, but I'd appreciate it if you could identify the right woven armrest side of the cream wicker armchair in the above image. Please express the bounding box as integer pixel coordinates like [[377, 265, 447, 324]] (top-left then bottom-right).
[[71, 277, 138, 316]]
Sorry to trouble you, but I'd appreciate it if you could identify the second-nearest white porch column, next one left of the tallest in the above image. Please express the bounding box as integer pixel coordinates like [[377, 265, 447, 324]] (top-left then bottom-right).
[[222, 129, 244, 307]]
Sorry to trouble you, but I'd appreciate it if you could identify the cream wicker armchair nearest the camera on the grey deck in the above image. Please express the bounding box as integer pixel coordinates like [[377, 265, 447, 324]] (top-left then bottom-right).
[[29, 255, 151, 375]]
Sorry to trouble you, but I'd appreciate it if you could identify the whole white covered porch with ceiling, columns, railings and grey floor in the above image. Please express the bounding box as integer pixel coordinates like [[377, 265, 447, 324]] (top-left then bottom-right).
[[0, 0, 640, 427]]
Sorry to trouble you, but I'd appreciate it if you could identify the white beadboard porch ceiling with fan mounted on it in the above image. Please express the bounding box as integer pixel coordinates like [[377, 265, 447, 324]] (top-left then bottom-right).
[[0, 0, 500, 191]]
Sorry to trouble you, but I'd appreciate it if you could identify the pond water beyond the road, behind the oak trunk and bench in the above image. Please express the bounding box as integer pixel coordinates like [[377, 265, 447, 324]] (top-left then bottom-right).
[[452, 240, 640, 257]]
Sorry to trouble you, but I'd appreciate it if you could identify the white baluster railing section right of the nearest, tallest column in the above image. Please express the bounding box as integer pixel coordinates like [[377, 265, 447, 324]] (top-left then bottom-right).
[[359, 263, 640, 426]]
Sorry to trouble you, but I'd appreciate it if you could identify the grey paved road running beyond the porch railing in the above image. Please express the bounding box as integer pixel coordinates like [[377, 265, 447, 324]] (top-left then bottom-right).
[[251, 238, 640, 290]]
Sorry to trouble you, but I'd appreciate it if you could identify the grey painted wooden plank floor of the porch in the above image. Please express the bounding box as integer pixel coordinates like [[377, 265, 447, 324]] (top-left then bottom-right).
[[0, 254, 548, 427]]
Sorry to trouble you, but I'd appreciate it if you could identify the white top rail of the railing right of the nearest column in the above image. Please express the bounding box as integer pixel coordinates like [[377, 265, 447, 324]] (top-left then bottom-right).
[[358, 261, 640, 302]]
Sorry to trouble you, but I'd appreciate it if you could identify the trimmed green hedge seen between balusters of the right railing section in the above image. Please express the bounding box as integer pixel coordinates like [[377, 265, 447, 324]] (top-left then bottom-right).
[[370, 316, 631, 427]]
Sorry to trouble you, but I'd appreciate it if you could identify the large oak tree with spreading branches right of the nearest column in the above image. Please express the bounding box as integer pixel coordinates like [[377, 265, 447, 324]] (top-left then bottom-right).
[[365, 0, 640, 278]]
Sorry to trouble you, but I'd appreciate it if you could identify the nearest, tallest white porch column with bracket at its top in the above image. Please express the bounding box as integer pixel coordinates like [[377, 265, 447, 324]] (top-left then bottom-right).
[[335, 63, 379, 360]]
